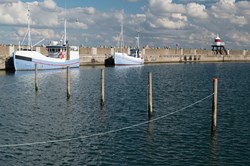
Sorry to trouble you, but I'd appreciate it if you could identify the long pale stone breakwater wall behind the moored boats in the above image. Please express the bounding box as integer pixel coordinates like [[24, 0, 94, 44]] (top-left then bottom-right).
[[0, 45, 250, 69]]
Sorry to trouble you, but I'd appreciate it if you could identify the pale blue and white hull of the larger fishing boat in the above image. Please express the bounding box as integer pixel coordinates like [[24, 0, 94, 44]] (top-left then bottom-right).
[[13, 51, 80, 70]]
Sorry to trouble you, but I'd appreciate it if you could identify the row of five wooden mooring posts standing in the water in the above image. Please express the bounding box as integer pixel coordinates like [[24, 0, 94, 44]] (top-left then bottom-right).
[[35, 67, 218, 133]]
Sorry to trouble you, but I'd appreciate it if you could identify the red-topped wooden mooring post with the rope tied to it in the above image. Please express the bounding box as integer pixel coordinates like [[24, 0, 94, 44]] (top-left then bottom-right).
[[211, 78, 218, 132]]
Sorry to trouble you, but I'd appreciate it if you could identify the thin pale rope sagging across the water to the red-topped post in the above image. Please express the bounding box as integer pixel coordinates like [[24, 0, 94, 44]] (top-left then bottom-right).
[[0, 93, 214, 148]]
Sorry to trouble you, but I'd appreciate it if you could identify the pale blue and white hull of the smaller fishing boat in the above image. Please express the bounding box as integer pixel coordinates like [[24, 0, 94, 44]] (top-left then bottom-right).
[[114, 53, 144, 65]]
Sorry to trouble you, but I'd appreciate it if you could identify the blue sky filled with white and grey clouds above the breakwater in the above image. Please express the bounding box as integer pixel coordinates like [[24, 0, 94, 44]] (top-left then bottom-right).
[[0, 0, 250, 49]]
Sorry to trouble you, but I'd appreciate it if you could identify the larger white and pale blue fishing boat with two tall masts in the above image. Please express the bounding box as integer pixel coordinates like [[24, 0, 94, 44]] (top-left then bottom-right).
[[13, 5, 80, 70]]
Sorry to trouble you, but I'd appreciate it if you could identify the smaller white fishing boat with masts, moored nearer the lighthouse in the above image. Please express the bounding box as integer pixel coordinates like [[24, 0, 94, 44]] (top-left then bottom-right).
[[114, 13, 144, 65]]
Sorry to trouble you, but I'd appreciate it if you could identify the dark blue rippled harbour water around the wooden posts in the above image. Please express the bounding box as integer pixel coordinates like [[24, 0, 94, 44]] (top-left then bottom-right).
[[0, 63, 250, 165]]
